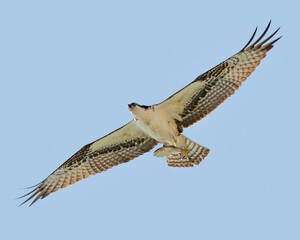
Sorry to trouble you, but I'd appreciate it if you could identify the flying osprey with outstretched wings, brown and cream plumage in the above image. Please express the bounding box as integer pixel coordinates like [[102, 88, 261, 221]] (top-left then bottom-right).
[[21, 21, 280, 206]]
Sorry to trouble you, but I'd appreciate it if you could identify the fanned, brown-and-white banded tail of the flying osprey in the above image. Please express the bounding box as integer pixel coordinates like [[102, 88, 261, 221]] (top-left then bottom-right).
[[167, 137, 210, 167]]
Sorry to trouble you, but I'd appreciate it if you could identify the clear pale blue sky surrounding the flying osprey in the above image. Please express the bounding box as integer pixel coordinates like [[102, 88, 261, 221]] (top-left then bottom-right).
[[0, 0, 300, 240]]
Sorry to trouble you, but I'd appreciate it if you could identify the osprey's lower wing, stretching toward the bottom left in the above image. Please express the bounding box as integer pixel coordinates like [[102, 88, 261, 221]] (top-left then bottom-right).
[[21, 121, 157, 206]]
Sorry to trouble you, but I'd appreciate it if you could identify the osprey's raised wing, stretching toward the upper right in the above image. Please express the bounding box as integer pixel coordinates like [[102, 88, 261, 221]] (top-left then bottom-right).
[[157, 21, 280, 128]]
